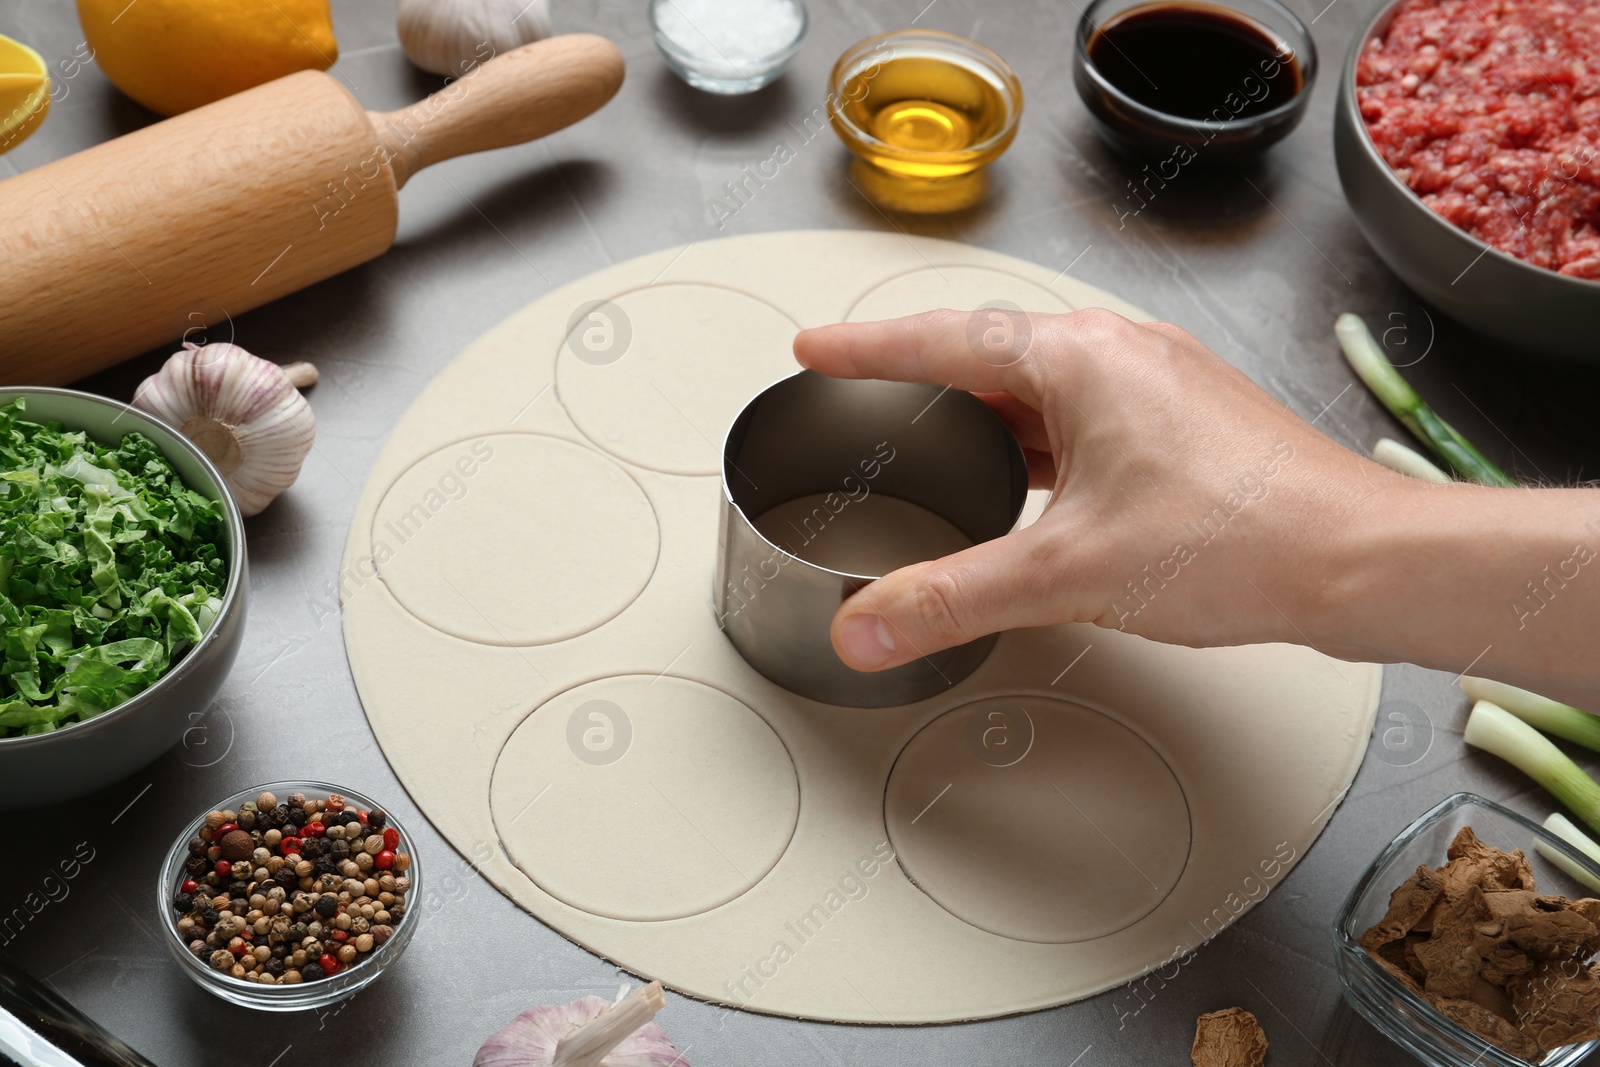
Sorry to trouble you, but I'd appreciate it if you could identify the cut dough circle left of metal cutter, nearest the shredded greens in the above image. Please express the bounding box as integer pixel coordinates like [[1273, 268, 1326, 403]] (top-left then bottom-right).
[[373, 434, 661, 645]]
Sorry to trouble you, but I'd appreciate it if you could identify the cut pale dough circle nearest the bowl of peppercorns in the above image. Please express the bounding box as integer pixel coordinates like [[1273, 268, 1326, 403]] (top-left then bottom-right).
[[490, 675, 800, 921]]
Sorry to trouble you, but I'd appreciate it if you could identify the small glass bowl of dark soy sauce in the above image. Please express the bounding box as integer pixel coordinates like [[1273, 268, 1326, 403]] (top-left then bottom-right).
[[1072, 0, 1317, 163]]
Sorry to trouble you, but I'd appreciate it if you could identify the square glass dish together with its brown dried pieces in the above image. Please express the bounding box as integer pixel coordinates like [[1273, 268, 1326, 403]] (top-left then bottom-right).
[[1333, 793, 1600, 1067]]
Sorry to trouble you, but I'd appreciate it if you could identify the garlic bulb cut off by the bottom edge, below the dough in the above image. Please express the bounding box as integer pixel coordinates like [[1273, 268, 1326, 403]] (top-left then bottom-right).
[[472, 982, 688, 1067]]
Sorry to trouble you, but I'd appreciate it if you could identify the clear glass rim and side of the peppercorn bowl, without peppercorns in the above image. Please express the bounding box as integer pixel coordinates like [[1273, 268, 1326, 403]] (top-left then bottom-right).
[[155, 782, 422, 1011]]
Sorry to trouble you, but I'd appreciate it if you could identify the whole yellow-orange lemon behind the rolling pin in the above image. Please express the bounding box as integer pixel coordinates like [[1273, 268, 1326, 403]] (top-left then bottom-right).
[[78, 0, 339, 115]]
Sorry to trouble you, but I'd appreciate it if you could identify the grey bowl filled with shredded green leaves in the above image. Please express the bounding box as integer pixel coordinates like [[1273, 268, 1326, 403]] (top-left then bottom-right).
[[0, 387, 246, 809]]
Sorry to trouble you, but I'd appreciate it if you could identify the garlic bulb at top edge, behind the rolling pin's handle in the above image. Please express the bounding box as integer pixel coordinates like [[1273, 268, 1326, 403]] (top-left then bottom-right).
[[400, 0, 552, 78]]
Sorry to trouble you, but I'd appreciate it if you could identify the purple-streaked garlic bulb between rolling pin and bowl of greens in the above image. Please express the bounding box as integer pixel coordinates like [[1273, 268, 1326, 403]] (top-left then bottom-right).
[[133, 342, 317, 515]]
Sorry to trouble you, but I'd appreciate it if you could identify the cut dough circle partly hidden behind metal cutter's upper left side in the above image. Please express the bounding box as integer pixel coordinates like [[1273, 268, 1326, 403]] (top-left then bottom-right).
[[555, 283, 800, 475]]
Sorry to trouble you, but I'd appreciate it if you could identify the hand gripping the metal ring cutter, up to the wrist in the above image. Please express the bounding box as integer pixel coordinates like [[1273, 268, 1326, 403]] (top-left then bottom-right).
[[795, 309, 1400, 670]]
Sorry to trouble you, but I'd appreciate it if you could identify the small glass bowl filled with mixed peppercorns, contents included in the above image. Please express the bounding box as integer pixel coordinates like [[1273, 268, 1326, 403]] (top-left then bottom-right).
[[155, 782, 421, 1011]]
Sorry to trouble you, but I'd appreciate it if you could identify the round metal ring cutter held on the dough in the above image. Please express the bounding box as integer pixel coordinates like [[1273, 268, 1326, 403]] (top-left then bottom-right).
[[714, 371, 1027, 707]]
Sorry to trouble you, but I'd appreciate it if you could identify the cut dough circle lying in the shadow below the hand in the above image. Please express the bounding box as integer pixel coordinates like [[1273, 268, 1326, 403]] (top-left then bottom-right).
[[883, 696, 1190, 944]]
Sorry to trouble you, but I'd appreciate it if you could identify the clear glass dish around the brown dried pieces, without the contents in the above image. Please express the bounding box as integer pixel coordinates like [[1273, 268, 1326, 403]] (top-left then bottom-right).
[[1333, 793, 1600, 1067]]
